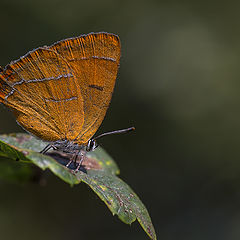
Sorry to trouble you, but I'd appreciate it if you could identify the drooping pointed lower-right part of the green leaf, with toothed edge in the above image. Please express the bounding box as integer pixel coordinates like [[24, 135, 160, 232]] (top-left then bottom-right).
[[77, 170, 157, 239]]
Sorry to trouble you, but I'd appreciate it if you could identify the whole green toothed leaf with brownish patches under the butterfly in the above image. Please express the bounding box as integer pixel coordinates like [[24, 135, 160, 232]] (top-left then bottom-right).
[[0, 134, 156, 239]]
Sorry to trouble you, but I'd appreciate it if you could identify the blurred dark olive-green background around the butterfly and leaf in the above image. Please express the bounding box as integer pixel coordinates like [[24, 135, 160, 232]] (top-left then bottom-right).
[[0, 0, 240, 240]]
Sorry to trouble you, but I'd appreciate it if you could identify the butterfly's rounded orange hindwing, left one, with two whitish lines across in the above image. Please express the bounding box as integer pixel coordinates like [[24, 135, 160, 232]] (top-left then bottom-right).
[[0, 48, 83, 141]]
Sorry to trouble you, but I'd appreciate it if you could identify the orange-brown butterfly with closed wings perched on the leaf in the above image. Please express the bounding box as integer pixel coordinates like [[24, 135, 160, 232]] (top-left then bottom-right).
[[0, 32, 134, 171]]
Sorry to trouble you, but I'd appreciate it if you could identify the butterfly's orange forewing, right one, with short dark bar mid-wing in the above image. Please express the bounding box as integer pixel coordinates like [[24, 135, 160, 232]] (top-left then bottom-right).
[[49, 33, 121, 144]]
